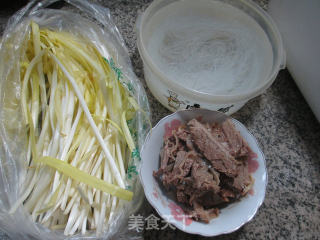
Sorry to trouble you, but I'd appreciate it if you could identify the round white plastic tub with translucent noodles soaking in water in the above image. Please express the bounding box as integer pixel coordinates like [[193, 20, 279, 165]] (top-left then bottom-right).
[[137, 0, 285, 114]]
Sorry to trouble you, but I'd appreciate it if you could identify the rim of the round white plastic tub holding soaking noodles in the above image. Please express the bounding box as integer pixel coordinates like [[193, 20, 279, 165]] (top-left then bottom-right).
[[136, 0, 286, 104]]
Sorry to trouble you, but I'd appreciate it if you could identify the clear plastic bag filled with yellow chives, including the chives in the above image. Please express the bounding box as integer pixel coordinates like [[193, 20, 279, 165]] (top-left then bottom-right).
[[0, 0, 150, 239]]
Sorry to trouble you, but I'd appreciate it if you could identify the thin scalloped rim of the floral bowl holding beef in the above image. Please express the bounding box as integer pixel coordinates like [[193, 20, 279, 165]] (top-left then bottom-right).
[[139, 108, 268, 237]]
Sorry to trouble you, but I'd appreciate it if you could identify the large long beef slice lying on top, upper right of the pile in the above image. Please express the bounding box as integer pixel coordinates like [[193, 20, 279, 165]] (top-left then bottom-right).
[[188, 119, 237, 177]]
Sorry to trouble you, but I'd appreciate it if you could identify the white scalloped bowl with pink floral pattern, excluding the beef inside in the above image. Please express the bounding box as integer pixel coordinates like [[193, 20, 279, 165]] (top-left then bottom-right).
[[140, 109, 267, 236]]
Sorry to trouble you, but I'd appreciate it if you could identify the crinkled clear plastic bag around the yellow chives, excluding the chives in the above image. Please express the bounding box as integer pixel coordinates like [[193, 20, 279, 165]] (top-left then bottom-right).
[[0, 0, 149, 239]]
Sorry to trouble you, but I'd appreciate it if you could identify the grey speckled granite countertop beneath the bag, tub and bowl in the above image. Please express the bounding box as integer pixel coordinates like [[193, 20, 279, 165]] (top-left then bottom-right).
[[0, 0, 320, 240]]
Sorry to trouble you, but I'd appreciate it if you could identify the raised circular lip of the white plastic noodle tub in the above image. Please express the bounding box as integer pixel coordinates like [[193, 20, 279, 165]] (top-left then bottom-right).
[[136, 0, 286, 105]]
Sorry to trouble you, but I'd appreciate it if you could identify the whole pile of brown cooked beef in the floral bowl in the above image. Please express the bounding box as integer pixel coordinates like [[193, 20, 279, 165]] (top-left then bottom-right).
[[153, 119, 253, 223]]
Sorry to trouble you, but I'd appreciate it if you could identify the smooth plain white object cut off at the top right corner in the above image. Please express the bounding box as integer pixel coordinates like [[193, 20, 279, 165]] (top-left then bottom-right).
[[268, 0, 320, 122]]
